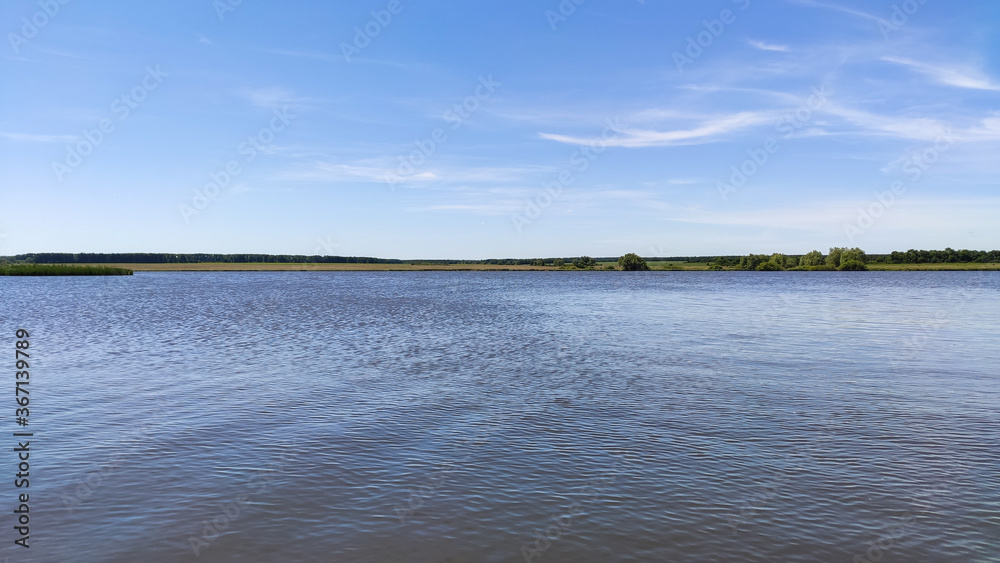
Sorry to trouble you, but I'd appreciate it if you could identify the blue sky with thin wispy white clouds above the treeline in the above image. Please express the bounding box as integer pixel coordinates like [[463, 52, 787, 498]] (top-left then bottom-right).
[[0, 0, 1000, 259]]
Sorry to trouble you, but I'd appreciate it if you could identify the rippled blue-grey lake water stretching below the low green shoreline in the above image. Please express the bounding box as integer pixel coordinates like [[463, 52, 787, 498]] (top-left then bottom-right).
[[0, 272, 1000, 563]]
